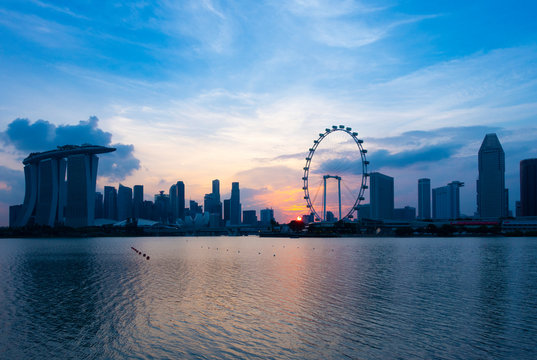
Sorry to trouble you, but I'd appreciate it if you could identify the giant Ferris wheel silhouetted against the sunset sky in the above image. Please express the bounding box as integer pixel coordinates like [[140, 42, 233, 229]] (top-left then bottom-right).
[[302, 125, 369, 221]]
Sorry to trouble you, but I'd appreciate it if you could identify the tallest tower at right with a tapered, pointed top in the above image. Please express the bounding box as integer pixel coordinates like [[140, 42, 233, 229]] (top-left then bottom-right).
[[477, 134, 508, 218]]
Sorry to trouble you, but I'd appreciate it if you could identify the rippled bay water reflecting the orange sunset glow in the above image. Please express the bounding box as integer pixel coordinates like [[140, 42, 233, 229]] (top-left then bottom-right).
[[0, 237, 537, 359]]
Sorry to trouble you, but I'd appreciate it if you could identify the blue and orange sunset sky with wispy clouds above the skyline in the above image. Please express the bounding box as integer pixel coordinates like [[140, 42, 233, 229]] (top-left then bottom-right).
[[0, 0, 537, 226]]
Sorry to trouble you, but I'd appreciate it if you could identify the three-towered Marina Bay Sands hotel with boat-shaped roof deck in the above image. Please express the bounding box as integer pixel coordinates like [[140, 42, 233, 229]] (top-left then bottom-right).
[[10, 145, 116, 227]]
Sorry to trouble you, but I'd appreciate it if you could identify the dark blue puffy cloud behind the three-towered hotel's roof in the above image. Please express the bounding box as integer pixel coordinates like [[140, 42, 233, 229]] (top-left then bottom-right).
[[0, 116, 140, 181]]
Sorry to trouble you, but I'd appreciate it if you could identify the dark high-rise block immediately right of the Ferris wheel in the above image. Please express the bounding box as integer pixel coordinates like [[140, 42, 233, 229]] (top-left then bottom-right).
[[369, 172, 394, 220]]
